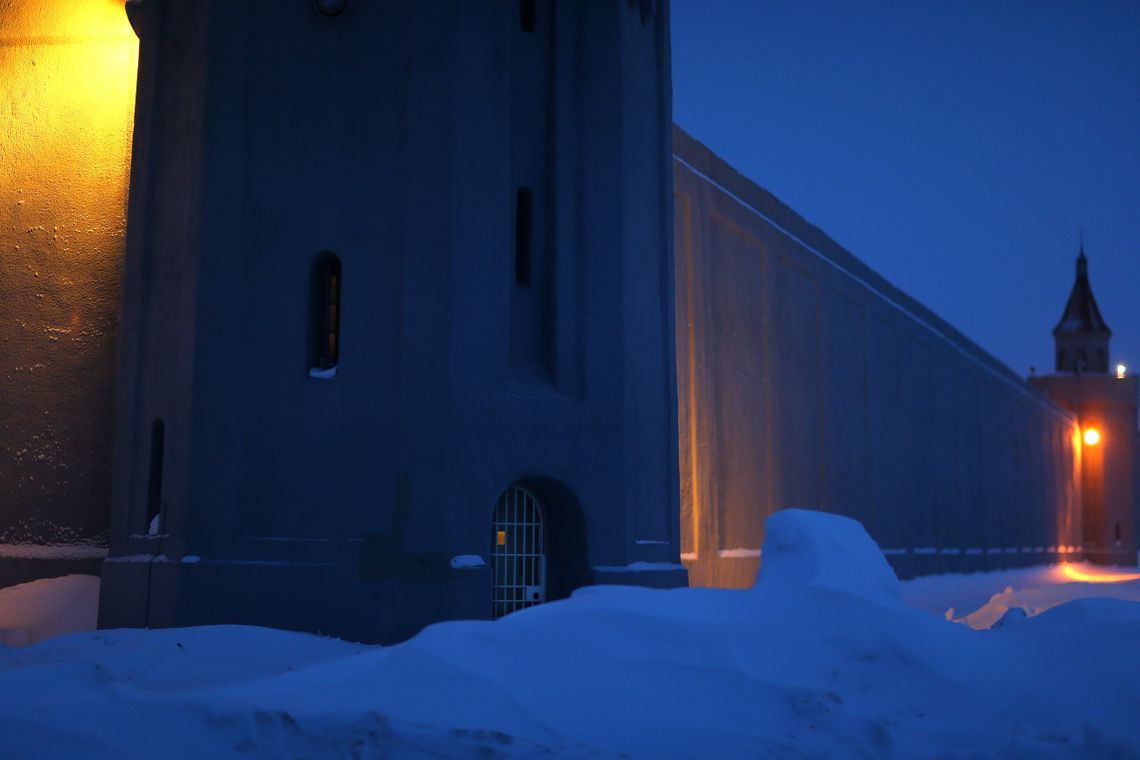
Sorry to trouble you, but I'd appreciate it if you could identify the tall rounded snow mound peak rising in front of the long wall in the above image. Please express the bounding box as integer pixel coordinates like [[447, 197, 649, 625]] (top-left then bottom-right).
[[756, 509, 902, 602]]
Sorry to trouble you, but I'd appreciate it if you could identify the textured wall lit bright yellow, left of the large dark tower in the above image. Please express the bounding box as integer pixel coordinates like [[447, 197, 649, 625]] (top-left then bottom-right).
[[0, 0, 137, 585]]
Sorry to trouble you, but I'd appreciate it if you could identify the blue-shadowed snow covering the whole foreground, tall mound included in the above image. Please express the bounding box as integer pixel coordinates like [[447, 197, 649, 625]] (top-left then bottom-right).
[[0, 510, 1140, 758]]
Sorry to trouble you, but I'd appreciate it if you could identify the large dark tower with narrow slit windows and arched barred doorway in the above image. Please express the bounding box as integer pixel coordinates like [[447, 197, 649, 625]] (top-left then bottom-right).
[[100, 0, 686, 641]]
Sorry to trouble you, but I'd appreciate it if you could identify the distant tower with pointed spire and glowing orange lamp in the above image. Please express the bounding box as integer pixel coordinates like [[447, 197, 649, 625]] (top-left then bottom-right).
[[1029, 243, 1140, 565]]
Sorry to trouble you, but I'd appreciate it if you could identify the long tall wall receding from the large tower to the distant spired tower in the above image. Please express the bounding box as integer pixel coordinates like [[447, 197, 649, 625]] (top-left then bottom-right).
[[673, 129, 1081, 587]]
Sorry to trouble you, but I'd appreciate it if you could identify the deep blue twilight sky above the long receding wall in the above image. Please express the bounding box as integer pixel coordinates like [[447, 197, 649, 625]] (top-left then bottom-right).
[[671, 0, 1140, 375]]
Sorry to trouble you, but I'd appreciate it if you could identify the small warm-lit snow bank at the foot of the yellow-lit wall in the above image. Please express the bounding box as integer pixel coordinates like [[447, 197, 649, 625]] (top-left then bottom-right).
[[0, 575, 99, 646]]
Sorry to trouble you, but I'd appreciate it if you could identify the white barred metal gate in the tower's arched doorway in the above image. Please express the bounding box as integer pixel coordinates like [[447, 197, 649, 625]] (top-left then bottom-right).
[[491, 485, 546, 619]]
